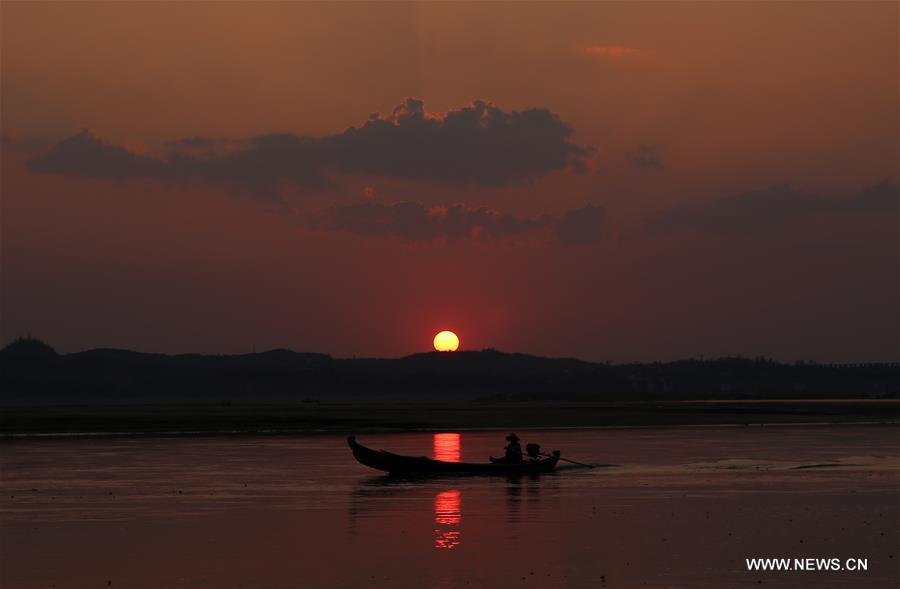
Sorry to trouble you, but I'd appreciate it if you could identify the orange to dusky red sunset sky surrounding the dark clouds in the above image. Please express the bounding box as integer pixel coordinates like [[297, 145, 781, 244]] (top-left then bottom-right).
[[0, 2, 900, 360]]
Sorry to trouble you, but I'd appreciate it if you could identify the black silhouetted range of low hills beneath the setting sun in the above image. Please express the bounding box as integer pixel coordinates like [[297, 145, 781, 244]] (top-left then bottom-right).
[[0, 338, 900, 403]]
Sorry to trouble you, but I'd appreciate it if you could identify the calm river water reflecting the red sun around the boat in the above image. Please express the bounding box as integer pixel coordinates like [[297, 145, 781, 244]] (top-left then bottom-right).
[[0, 426, 900, 589]]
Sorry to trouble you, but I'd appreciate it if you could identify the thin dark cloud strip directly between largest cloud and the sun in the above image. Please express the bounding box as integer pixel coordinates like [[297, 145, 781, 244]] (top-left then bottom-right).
[[307, 201, 552, 242]]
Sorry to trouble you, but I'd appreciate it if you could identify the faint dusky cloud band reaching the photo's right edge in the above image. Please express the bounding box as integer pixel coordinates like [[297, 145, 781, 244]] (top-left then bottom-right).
[[645, 182, 900, 234]]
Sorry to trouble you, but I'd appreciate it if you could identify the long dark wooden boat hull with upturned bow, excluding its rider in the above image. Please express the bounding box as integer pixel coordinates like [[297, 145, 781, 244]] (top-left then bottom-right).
[[347, 436, 559, 475]]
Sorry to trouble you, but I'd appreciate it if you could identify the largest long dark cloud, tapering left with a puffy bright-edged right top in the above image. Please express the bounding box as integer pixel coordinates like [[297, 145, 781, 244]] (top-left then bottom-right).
[[30, 98, 591, 189]]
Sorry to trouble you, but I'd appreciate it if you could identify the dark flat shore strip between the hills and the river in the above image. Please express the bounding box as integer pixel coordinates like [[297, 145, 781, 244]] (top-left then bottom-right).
[[0, 399, 900, 441]]
